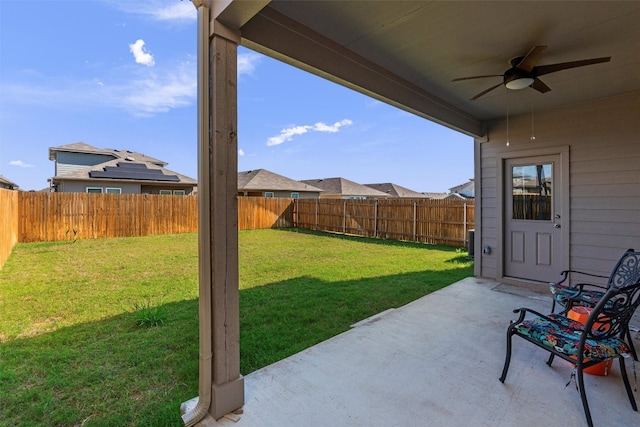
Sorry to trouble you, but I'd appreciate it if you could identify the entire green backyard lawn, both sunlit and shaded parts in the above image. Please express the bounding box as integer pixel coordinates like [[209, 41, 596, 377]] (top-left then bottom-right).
[[0, 230, 472, 427]]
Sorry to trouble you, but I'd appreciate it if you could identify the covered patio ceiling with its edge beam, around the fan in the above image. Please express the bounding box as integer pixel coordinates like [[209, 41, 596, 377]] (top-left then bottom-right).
[[214, 0, 640, 136]]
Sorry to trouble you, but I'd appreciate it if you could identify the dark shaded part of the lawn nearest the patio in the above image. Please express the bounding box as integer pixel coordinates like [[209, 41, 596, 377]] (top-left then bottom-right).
[[0, 266, 470, 427]]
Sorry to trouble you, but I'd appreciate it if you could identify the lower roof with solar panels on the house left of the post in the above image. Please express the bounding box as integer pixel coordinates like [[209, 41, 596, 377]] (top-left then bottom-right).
[[52, 159, 197, 185]]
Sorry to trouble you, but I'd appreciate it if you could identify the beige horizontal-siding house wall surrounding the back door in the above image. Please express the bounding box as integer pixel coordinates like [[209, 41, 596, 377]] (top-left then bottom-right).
[[475, 92, 640, 279]]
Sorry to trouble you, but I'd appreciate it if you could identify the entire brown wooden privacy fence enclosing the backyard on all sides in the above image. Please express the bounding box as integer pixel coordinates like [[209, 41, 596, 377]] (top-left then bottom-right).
[[5, 191, 474, 246]]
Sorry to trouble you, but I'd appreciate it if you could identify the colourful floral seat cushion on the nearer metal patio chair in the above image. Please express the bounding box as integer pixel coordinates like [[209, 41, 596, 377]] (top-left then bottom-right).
[[516, 314, 629, 360]]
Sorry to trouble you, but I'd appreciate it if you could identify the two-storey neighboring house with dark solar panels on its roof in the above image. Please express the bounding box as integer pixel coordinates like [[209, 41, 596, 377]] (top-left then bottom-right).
[[49, 142, 197, 195]]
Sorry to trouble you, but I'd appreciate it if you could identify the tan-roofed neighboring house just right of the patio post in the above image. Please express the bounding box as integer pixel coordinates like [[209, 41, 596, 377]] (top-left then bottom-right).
[[238, 169, 323, 199]]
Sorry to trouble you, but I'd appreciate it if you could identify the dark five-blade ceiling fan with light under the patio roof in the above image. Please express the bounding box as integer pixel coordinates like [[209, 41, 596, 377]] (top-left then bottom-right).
[[451, 46, 611, 101]]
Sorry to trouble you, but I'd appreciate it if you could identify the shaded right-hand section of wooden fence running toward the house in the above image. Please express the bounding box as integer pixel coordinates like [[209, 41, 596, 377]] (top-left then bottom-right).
[[294, 199, 475, 246]]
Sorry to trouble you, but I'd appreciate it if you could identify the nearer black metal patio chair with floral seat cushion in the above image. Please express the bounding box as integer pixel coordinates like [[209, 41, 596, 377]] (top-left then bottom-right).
[[500, 282, 640, 427]]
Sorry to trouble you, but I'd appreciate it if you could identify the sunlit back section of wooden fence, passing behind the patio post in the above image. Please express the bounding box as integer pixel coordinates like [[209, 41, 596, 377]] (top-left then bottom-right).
[[12, 192, 293, 242]]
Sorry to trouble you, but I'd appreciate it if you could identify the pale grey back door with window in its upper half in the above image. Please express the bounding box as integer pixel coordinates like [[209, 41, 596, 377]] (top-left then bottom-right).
[[503, 155, 564, 283]]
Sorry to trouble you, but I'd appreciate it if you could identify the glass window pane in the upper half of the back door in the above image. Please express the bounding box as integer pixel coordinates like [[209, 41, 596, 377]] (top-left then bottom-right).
[[511, 163, 553, 221]]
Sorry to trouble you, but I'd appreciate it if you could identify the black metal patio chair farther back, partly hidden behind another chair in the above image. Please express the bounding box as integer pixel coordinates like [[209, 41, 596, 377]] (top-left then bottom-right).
[[550, 249, 640, 360]]
